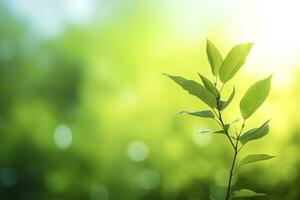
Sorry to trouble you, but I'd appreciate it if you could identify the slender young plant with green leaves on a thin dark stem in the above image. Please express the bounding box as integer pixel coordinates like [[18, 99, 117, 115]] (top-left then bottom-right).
[[165, 40, 274, 200]]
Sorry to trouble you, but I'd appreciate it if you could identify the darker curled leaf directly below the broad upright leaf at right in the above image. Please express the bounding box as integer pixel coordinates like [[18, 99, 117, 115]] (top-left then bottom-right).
[[239, 120, 270, 144]]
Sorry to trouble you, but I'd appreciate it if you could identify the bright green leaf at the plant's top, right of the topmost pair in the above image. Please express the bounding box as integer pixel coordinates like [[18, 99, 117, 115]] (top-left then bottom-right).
[[219, 43, 253, 83]]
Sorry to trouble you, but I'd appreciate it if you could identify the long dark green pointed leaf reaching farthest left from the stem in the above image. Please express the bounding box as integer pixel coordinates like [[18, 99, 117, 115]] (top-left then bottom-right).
[[164, 74, 217, 108]]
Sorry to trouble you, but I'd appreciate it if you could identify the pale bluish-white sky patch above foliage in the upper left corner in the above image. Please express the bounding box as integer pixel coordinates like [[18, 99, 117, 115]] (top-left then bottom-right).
[[5, 0, 98, 38]]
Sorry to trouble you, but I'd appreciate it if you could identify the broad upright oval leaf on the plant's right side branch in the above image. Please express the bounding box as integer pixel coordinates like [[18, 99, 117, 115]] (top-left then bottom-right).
[[240, 76, 272, 119]]
